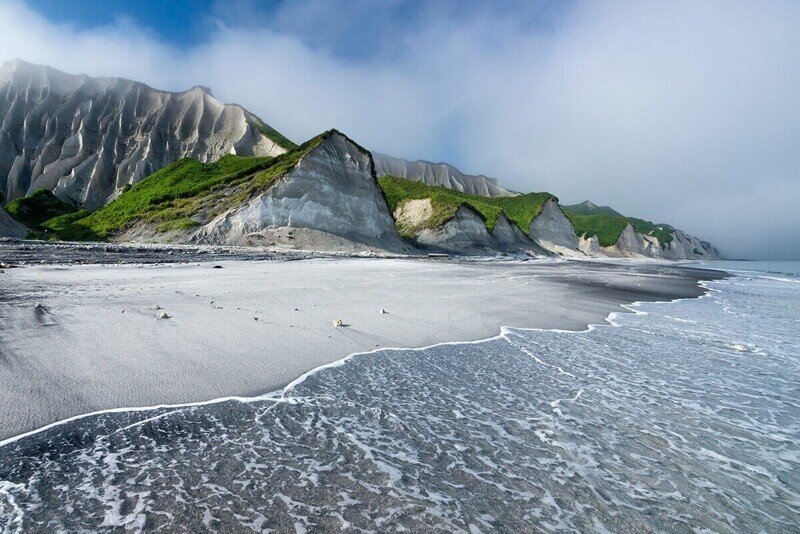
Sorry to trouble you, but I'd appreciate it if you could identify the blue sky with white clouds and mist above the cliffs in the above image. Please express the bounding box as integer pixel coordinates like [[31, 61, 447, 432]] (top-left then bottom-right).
[[0, 0, 800, 259]]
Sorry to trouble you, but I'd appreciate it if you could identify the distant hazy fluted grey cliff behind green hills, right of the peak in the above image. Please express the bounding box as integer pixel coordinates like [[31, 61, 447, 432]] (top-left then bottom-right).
[[373, 153, 517, 197]]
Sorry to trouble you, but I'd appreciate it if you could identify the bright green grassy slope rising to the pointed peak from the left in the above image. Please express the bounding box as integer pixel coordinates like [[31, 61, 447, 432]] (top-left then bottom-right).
[[36, 132, 328, 240]]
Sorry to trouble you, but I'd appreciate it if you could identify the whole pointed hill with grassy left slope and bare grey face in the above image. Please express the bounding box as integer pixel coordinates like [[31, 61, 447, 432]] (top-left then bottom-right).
[[41, 130, 409, 251]]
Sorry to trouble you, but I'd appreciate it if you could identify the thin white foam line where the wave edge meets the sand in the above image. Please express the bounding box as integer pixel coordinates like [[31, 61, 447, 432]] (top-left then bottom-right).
[[0, 271, 724, 448]]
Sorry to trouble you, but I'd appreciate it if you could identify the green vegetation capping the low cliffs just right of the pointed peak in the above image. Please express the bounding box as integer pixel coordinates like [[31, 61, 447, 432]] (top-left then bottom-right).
[[378, 175, 558, 237]]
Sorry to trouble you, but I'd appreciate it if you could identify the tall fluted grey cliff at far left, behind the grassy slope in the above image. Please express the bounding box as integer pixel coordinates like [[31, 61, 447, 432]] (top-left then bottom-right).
[[0, 61, 289, 209]]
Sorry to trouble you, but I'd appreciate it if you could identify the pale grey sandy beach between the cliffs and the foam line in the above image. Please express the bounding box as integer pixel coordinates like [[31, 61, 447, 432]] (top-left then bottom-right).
[[0, 255, 724, 443]]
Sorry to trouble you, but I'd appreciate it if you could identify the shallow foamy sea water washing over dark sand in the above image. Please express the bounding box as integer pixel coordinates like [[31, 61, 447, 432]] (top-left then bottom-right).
[[0, 263, 800, 532]]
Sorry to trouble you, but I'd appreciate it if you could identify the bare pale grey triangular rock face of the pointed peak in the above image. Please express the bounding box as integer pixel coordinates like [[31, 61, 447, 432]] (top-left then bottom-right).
[[193, 132, 409, 251]]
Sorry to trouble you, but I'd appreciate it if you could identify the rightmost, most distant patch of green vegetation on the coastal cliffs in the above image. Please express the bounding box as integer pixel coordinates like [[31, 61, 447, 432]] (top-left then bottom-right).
[[563, 203, 675, 247]]
